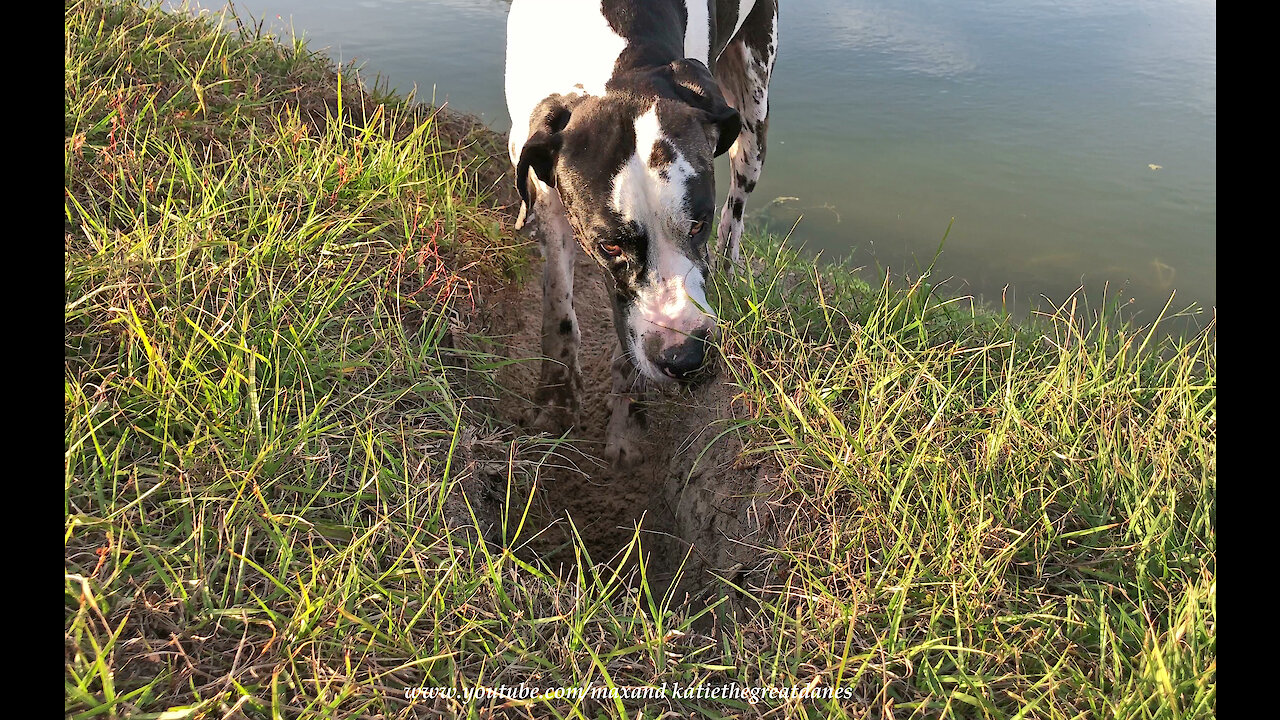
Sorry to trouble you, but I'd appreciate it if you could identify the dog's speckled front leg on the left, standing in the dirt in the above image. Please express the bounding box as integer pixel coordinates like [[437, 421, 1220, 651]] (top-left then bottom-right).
[[529, 188, 582, 434]]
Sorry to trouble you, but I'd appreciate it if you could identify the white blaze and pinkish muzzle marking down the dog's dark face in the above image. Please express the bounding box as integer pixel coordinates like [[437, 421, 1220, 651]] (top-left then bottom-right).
[[611, 105, 714, 377]]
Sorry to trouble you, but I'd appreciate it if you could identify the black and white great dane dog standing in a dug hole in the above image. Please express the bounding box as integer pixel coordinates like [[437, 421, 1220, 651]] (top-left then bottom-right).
[[506, 0, 778, 466]]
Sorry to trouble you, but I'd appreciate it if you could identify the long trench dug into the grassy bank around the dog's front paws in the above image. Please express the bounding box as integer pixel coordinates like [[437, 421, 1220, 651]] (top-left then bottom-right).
[[435, 112, 780, 610]]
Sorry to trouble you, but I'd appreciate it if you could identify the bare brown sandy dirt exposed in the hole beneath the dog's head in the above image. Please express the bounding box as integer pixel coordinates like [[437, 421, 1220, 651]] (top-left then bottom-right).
[[466, 243, 776, 594]]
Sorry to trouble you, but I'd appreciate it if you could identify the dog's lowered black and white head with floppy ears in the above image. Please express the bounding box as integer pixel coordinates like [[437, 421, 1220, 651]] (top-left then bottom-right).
[[516, 59, 740, 383]]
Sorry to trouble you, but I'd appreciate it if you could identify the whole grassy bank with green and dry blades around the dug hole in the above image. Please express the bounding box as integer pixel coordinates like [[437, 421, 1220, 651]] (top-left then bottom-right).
[[64, 1, 1217, 717]]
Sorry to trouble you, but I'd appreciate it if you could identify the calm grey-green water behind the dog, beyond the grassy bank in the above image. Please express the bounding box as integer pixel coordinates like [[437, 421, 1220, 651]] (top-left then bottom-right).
[[222, 0, 1217, 324]]
